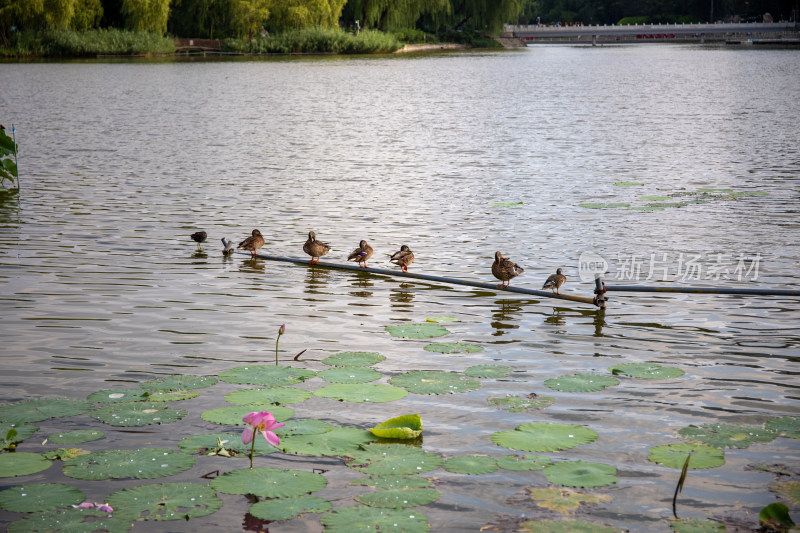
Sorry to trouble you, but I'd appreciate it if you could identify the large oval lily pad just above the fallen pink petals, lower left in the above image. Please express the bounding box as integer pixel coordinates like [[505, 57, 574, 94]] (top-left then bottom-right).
[[64, 448, 195, 481]]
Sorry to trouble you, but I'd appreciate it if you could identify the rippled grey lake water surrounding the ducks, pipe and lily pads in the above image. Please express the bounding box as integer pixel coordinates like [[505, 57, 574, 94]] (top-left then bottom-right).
[[0, 45, 800, 532]]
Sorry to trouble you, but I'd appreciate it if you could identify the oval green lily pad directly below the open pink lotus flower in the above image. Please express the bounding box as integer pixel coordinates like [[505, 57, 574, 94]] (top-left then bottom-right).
[[211, 468, 328, 498]]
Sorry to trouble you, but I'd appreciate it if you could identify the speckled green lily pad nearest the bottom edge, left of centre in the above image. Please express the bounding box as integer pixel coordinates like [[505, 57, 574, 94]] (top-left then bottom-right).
[[320, 505, 431, 533]]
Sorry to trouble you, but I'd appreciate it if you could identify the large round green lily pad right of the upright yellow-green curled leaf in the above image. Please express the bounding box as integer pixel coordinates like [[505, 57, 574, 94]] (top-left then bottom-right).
[[491, 422, 598, 452]]
